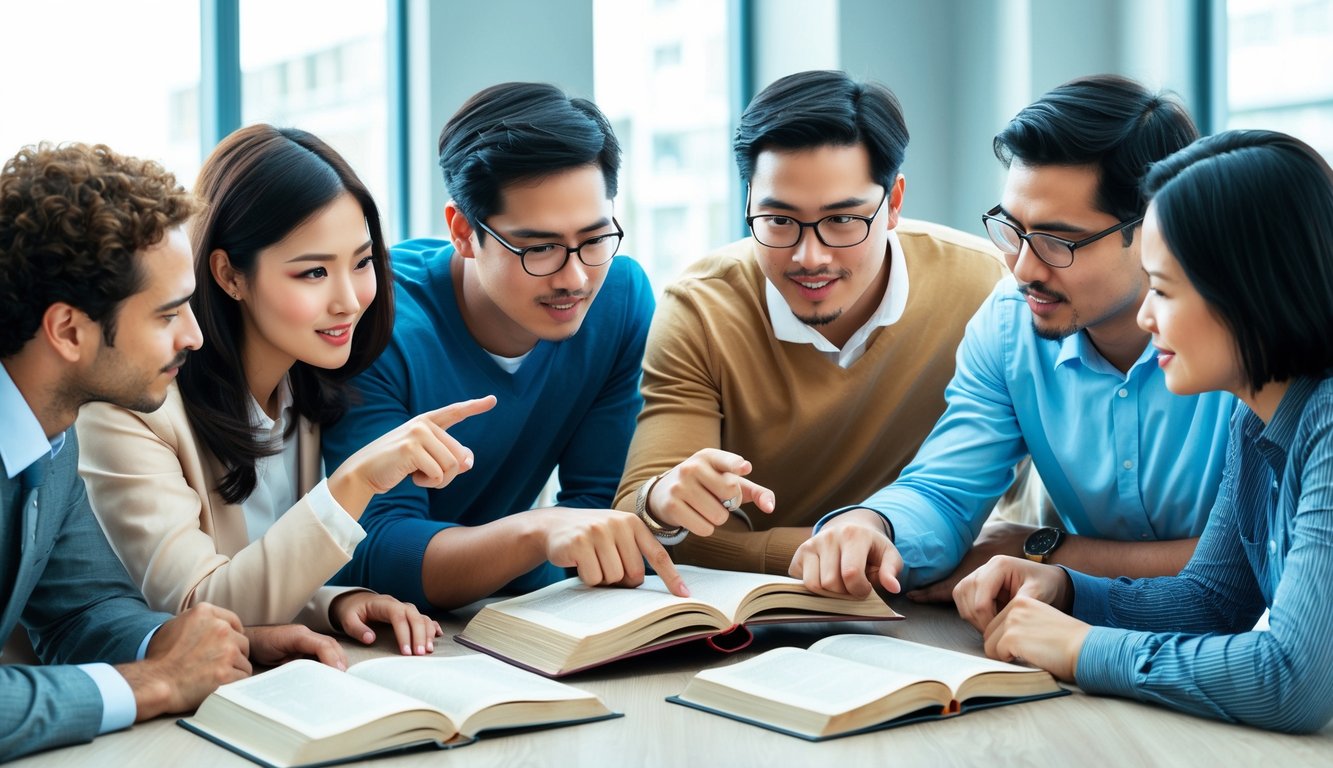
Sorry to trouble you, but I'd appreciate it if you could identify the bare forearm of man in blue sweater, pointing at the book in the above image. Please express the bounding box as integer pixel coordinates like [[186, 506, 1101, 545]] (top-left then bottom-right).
[[421, 509, 557, 609]]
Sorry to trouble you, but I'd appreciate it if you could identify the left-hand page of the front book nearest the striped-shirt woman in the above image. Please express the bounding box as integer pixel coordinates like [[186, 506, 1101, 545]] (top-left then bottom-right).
[[696, 648, 924, 716]]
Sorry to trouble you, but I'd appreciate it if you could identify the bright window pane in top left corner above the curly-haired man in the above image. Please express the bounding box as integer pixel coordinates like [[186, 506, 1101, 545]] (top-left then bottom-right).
[[0, 0, 200, 188]]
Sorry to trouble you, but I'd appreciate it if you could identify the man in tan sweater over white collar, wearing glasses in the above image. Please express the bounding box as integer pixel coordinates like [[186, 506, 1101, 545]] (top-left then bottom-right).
[[616, 72, 1002, 573]]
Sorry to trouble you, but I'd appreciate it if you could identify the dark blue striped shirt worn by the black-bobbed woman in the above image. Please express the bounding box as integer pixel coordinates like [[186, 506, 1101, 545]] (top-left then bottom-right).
[[1069, 379, 1333, 732]]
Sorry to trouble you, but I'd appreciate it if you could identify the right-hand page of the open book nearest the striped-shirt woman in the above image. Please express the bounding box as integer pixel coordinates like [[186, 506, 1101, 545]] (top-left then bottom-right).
[[810, 635, 1032, 691]]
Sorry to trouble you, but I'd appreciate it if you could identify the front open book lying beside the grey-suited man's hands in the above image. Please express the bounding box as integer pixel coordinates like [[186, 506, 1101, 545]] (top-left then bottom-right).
[[179, 655, 617, 768]]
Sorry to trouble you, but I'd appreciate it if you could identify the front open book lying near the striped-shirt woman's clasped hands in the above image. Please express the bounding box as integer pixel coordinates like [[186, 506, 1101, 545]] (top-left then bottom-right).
[[667, 635, 1068, 741]]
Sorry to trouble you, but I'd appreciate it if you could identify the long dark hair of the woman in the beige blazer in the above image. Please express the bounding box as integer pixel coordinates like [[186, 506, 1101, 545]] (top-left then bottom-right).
[[180, 124, 393, 504]]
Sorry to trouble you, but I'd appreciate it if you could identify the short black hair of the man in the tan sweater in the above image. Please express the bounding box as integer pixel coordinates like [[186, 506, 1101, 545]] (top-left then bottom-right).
[[732, 71, 908, 189]]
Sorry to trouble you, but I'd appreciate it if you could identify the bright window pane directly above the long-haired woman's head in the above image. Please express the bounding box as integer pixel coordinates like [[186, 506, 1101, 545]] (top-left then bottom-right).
[[240, 0, 389, 239]]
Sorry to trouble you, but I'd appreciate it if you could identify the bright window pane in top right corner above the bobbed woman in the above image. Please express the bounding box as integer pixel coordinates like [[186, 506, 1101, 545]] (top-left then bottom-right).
[[1226, 0, 1333, 159]]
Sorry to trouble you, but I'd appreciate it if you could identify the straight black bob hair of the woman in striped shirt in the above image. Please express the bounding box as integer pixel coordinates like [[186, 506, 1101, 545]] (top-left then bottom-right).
[[1144, 131, 1333, 391]]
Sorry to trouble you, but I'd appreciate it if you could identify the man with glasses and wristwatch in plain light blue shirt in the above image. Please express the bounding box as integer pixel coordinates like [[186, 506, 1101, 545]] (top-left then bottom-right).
[[792, 76, 1234, 599]]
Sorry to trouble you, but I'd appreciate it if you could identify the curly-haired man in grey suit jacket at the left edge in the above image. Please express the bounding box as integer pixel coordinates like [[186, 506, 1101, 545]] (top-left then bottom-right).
[[0, 144, 345, 760]]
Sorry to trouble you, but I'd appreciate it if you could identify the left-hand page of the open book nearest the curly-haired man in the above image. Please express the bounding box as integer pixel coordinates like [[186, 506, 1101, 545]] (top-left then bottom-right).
[[213, 659, 437, 739]]
